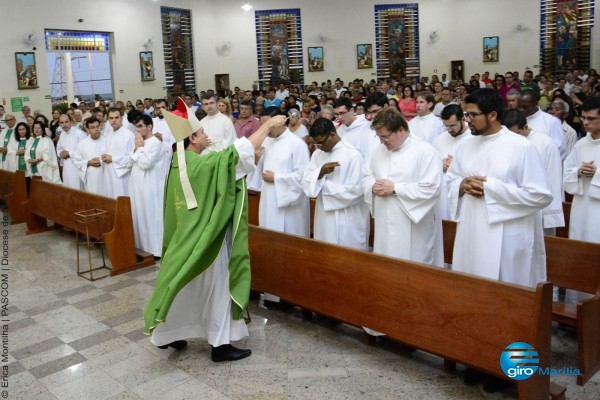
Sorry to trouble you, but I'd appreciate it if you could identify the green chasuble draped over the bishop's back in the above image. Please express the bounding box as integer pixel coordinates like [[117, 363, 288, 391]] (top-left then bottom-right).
[[144, 145, 250, 334]]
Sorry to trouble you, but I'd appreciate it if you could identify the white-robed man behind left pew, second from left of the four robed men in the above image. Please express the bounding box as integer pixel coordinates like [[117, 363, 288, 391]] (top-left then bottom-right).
[[75, 117, 106, 196]]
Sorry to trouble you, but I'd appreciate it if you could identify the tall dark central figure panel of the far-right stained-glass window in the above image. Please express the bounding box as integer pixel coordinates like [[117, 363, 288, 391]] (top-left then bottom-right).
[[556, 0, 577, 69]]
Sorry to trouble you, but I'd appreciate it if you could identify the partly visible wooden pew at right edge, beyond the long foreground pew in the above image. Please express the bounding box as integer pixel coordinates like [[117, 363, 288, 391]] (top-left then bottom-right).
[[545, 236, 600, 385]]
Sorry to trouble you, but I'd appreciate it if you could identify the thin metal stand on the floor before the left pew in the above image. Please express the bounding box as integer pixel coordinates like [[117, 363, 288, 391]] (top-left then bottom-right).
[[75, 209, 112, 281]]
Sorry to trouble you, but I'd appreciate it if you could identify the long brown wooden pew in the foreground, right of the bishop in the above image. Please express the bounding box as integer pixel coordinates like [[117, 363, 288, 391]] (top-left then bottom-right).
[[249, 226, 552, 400]]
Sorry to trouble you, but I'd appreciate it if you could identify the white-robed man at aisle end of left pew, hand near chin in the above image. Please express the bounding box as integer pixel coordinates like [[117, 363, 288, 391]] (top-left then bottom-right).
[[127, 114, 166, 257]]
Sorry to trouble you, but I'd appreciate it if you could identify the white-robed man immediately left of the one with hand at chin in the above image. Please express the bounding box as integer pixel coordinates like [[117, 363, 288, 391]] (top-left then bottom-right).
[[102, 108, 134, 198]]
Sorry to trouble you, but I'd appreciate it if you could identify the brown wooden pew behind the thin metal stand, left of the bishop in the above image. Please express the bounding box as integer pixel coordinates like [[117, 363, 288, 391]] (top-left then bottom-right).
[[25, 179, 155, 275]]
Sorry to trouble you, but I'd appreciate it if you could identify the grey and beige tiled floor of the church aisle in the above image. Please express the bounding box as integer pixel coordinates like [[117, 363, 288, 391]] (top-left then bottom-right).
[[0, 211, 600, 400]]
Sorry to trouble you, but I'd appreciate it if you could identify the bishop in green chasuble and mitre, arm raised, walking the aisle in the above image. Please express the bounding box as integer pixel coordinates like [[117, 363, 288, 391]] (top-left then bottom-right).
[[144, 99, 285, 361]]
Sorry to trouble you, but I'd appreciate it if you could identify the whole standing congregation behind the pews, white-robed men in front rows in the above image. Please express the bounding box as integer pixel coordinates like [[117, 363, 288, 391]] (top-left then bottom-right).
[[0, 69, 600, 378]]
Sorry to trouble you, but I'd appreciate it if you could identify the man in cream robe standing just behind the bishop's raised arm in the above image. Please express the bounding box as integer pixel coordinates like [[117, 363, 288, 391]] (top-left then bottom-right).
[[200, 93, 236, 155]]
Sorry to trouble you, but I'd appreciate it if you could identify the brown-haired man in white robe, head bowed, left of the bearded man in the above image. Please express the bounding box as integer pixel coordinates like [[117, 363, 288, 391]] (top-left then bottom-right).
[[363, 108, 444, 267]]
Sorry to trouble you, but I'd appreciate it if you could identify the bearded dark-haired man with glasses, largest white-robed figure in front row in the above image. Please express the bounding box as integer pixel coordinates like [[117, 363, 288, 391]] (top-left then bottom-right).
[[446, 88, 552, 392]]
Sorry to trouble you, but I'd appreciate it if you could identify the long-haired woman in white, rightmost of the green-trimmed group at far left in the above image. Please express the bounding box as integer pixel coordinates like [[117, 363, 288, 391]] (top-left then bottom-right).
[[25, 121, 61, 183]]
